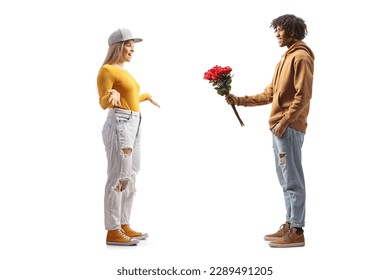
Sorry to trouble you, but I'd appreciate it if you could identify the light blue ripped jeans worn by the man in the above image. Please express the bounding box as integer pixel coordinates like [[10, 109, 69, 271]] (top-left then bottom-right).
[[272, 127, 306, 227]]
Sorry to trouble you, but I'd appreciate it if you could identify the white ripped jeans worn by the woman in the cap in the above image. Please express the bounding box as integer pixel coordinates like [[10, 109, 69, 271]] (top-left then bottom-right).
[[102, 109, 141, 230]]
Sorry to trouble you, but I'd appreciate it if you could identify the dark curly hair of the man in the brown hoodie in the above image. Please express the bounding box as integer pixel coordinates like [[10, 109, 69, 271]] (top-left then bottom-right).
[[270, 14, 307, 40]]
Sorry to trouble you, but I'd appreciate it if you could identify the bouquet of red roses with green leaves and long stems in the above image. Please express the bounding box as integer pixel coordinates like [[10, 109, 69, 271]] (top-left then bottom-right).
[[203, 65, 244, 126]]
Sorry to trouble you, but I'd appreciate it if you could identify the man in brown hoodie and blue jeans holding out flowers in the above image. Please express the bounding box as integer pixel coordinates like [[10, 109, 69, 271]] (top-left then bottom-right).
[[226, 14, 314, 248]]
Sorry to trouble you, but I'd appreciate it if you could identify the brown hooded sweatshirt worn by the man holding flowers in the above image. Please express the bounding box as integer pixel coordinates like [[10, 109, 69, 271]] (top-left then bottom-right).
[[239, 41, 314, 133]]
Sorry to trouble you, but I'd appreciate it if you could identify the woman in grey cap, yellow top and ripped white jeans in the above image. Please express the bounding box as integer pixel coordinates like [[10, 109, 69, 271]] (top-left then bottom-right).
[[97, 28, 160, 245]]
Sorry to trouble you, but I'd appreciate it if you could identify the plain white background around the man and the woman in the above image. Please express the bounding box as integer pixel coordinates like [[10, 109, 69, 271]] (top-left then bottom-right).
[[0, 0, 390, 279]]
